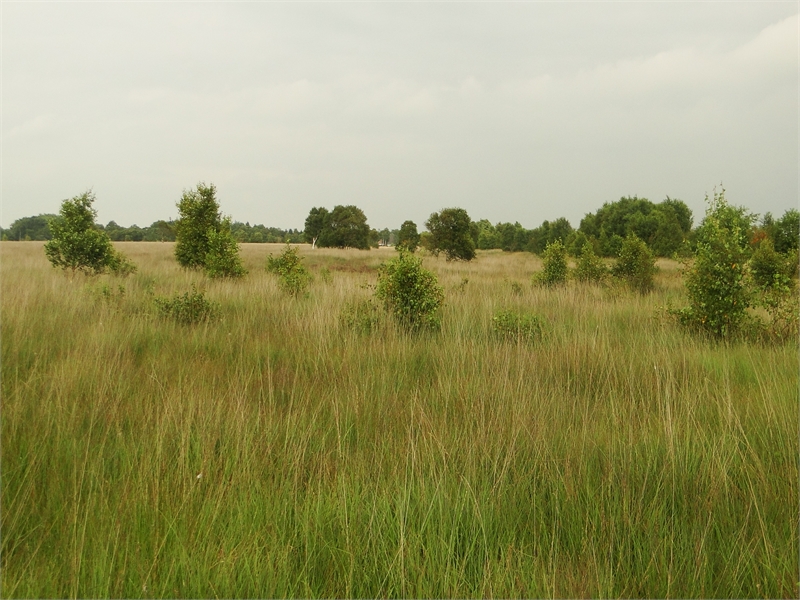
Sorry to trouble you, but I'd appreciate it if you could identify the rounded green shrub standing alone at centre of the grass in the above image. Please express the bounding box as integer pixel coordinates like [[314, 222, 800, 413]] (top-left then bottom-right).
[[375, 249, 444, 330]]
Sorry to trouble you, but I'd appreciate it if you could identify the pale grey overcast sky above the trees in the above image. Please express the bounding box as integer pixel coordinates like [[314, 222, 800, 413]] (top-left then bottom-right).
[[0, 1, 800, 229]]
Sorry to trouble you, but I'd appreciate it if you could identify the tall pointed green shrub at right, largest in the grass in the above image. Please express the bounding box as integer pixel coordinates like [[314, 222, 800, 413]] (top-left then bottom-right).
[[672, 190, 749, 338]]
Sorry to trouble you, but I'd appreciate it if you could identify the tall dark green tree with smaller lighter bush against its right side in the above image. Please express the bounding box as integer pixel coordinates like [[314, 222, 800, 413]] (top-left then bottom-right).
[[175, 182, 222, 269]]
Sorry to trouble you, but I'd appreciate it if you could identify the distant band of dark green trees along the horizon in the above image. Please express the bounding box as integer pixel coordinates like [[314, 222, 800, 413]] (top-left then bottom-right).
[[7, 186, 800, 260]]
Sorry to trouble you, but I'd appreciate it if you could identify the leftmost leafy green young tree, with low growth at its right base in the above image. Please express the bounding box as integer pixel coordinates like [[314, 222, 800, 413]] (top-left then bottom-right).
[[44, 191, 136, 275]]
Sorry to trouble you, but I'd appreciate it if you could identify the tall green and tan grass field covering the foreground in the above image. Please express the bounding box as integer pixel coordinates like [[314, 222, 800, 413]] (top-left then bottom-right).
[[0, 242, 800, 598]]
